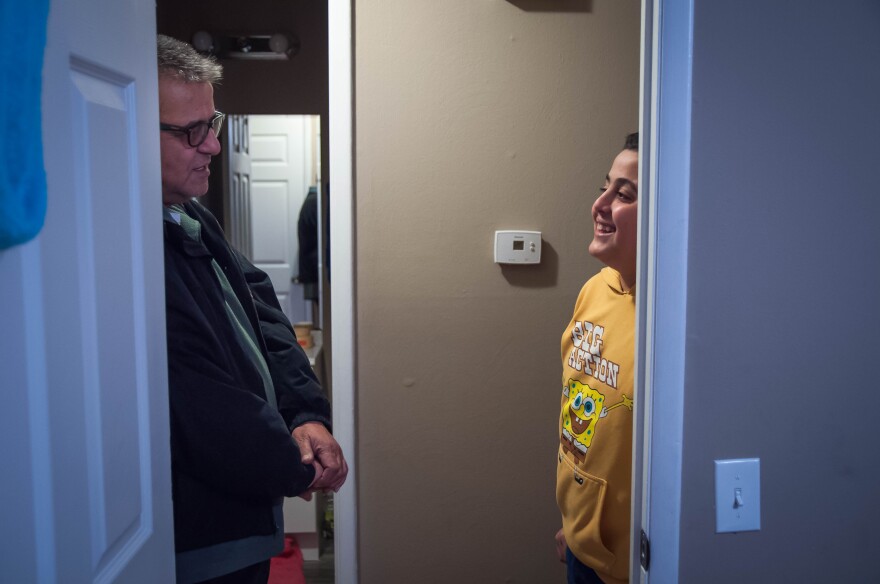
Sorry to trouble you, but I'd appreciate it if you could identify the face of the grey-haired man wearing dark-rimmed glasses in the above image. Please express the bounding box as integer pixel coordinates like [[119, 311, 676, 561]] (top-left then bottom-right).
[[159, 77, 220, 205]]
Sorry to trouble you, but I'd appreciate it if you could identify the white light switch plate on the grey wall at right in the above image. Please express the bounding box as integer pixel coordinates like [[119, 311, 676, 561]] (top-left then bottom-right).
[[715, 458, 761, 533]]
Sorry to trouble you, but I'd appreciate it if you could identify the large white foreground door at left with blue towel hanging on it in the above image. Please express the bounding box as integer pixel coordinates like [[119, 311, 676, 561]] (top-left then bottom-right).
[[0, 0, 174, 584]]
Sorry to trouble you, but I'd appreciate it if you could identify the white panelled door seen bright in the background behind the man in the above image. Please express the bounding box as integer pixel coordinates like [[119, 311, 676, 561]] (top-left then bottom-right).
[[250, 116, 317, 322]]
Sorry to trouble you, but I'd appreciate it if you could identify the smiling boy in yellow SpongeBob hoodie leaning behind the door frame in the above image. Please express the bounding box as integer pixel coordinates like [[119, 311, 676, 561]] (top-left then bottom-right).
[[556, 133, 639, 584]]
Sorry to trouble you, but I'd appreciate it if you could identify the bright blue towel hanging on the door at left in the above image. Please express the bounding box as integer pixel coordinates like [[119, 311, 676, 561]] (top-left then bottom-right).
[[0, 0, 49, 249]]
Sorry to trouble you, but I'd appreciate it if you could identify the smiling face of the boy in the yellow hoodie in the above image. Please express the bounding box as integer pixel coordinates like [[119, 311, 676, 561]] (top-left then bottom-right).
[[590, 150, 639, 287]]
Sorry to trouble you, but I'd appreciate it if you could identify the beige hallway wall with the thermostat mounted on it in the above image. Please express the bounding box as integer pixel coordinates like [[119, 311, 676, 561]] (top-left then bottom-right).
[[354, 0, 639, 584]]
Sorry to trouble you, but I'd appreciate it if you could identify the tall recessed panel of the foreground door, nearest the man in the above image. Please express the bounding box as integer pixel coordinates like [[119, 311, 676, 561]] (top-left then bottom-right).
[[70, 59, 151, 574]]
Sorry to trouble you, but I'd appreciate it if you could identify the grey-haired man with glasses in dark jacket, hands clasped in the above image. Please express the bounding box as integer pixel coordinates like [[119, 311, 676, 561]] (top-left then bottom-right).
[[158, 35, 348, 584]]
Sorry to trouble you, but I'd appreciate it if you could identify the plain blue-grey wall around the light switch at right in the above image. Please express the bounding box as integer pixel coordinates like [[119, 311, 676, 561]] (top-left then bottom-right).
[[680, 0, 880, 584]]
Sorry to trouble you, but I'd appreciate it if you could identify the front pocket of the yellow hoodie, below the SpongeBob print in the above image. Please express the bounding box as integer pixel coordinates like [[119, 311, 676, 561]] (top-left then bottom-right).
[[556, 448, 615, 574]]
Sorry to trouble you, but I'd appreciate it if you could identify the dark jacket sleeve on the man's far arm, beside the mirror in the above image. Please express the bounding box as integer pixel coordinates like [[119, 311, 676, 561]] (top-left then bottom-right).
[[236, 244, 332, 430]]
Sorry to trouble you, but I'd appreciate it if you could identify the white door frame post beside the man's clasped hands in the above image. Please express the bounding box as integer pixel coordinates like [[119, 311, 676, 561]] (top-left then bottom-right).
[[327, 0, 358, 584]]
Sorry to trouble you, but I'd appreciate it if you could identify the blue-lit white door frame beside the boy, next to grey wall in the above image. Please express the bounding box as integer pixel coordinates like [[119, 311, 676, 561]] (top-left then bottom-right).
[[631, 0, 693, 584]]
